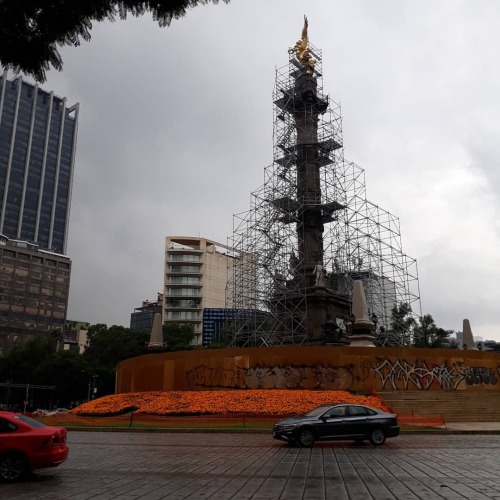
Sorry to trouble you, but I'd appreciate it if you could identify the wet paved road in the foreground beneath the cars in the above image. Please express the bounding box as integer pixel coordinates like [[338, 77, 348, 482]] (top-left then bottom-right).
[[0, 432, 500, 500]]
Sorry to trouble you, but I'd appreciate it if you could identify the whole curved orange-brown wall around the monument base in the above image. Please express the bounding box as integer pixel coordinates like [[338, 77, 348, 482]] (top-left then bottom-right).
[[116, 346, 500, 393]]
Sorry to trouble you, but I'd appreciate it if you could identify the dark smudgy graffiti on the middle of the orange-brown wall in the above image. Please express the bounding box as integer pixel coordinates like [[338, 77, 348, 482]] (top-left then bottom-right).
[[186, 365, 360, 390]]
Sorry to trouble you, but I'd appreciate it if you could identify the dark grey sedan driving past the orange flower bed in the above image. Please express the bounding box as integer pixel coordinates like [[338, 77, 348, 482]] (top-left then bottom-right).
[[273, 404, 399, 446]]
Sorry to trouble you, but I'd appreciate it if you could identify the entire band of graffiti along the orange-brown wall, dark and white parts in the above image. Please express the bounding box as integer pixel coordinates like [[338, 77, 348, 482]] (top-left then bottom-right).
[[186, 358, 500, 391]]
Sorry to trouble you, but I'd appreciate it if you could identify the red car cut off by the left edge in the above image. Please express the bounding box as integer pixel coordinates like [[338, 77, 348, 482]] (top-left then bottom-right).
[[0, 411, 68, 482]]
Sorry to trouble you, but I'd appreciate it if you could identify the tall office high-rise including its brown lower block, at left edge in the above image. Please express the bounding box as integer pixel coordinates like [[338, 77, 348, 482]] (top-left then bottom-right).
[[0, 71, 79, 355]]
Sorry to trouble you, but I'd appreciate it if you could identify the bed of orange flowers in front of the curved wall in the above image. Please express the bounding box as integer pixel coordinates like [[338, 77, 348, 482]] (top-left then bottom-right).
[[71, 389, 390, 417]]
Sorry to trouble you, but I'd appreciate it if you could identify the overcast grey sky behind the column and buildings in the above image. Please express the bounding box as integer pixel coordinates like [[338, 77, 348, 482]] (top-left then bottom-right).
[[32, 0, 500, 341]]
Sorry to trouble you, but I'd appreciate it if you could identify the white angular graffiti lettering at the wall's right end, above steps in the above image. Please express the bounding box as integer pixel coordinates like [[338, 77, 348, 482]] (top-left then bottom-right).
[[373, 358, 500, 391]]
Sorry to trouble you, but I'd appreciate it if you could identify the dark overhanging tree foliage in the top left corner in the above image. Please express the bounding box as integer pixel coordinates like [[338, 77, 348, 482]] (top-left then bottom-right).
[[0, 0, 229, 82]]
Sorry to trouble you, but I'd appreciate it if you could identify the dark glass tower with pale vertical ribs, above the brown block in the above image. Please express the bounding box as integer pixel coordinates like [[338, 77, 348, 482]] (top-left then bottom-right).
[[0, 71, 79, 254]]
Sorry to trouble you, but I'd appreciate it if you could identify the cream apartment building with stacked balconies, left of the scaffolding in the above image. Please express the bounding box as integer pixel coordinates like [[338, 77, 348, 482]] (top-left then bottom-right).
[[163, 236, 233, 345]]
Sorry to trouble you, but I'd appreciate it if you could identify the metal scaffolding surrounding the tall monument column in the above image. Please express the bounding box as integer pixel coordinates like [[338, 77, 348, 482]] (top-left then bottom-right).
[[226, 43, 421, 346]]
